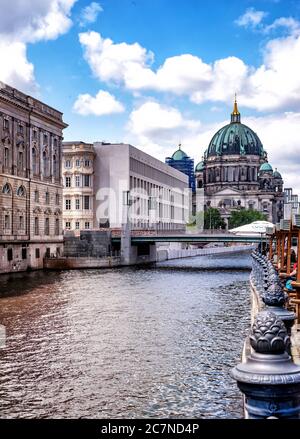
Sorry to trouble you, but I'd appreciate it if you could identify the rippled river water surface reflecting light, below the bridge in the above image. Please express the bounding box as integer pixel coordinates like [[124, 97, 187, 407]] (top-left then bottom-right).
[[0, 255, 250, 418]]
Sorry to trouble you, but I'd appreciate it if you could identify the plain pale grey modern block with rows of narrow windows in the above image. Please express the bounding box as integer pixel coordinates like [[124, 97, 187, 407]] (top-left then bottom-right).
[[94, 143, 190, 230]]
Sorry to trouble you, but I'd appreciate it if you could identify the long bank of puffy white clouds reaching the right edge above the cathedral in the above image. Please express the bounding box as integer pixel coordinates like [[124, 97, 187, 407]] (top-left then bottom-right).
[[79, 27, 300, 111]]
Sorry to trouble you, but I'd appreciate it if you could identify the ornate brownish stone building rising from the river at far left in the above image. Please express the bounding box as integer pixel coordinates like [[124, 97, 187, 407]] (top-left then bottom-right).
[[0, 83, 67, 273]]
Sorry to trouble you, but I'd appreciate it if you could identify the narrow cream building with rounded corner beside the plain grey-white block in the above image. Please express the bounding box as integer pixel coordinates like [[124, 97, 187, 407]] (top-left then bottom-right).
[[62, 142, 97, 233]]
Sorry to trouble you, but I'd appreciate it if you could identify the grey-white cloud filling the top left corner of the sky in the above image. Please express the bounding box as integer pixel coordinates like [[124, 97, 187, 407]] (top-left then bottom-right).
[[0, 0, 76, 93]]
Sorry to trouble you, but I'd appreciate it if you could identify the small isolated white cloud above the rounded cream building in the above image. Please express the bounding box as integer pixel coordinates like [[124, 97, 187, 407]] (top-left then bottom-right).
[[73, 90, 125, 116]]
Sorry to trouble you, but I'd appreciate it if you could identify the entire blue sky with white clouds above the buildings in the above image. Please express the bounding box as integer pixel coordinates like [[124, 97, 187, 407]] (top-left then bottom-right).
[[0, 0, 300, 195]]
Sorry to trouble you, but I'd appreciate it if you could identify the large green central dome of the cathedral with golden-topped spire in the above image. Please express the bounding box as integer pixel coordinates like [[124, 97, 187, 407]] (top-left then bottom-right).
[[206, 100, 265, 158]]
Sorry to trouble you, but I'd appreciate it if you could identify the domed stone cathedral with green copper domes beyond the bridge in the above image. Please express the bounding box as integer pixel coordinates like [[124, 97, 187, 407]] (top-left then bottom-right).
[[195, 101, 284, 227]]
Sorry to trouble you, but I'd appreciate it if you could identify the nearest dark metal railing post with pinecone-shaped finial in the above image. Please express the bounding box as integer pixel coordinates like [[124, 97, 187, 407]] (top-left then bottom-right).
[[231, 311, 300, 419]]
